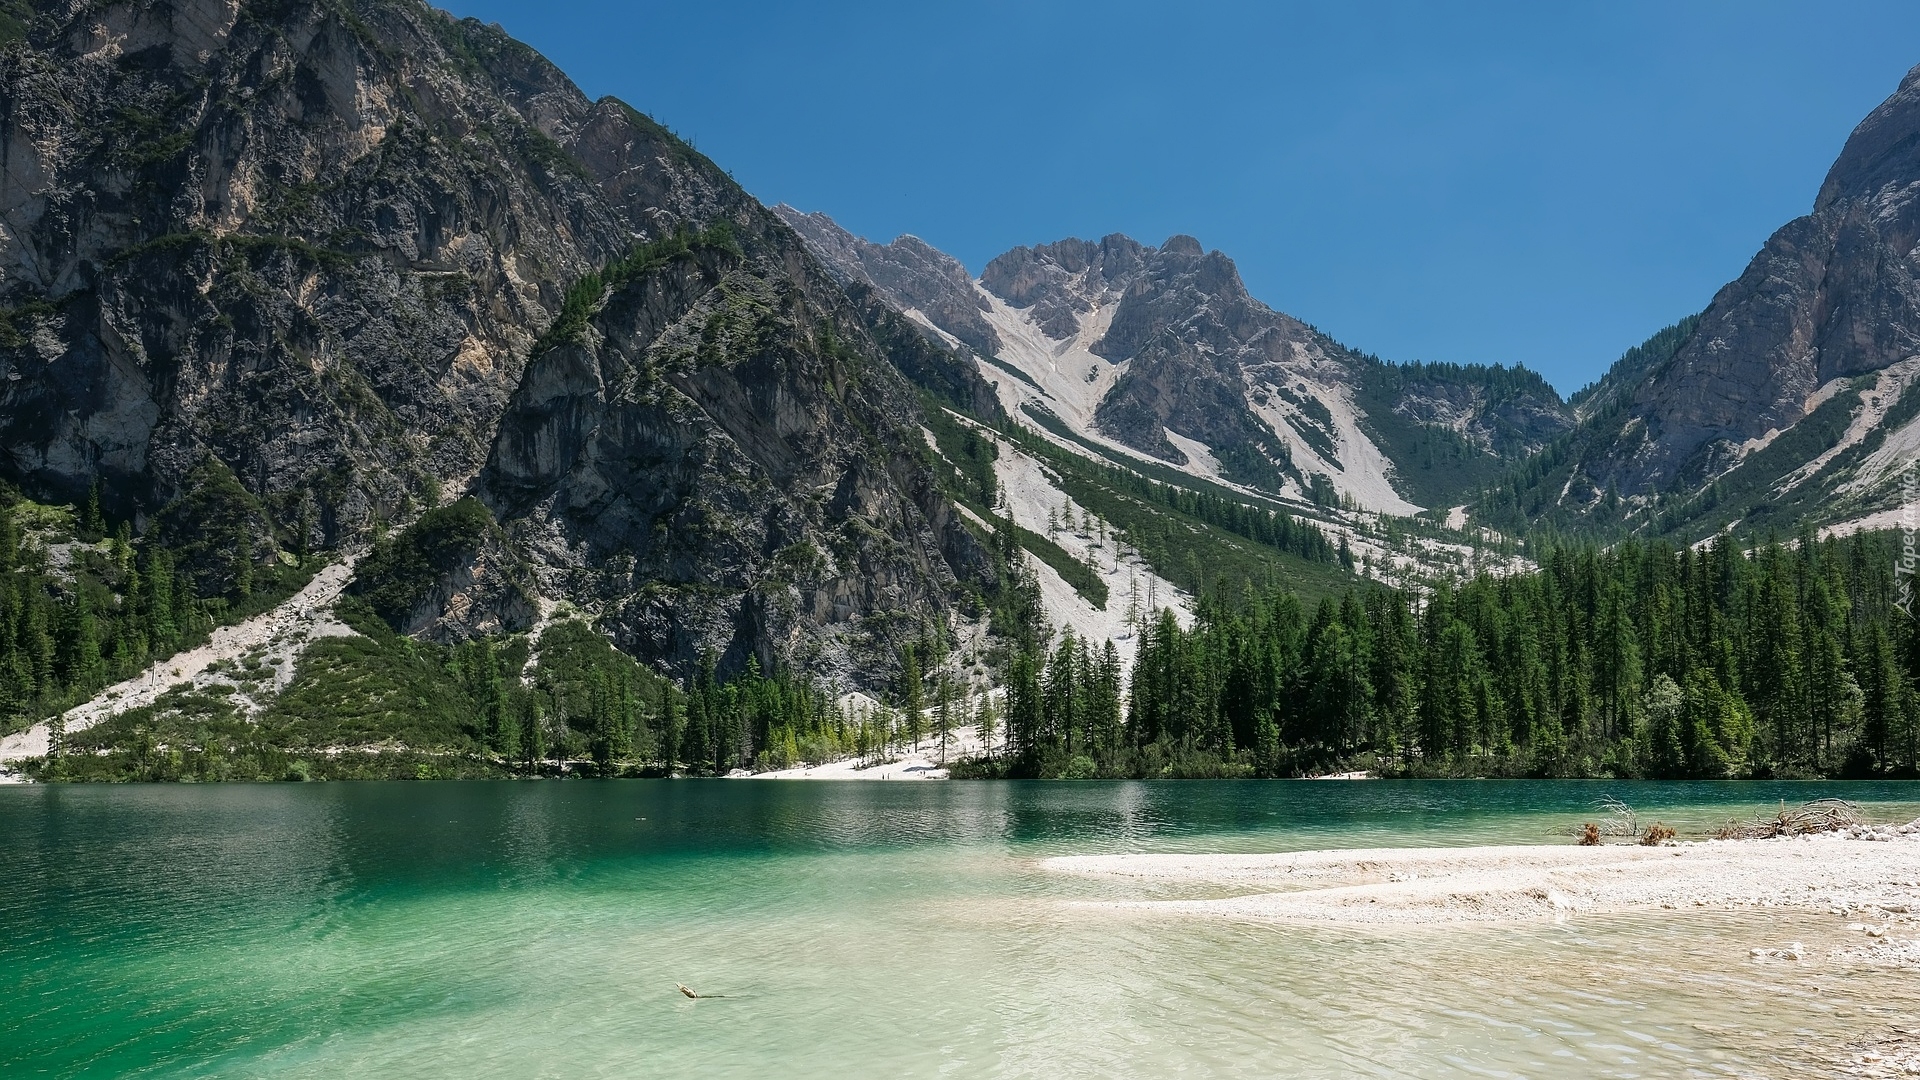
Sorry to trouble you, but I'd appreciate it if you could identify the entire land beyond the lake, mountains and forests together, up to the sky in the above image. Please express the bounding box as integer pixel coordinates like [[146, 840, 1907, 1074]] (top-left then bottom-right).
[[0, 0, 1920, 778]]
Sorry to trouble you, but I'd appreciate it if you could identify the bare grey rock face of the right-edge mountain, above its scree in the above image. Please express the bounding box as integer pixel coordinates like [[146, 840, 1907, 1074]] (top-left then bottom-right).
[[1590, 67, 1920, 494]]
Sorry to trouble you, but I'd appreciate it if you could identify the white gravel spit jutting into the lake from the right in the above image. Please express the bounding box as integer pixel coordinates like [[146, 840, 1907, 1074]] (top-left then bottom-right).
[[1043, 821, 1920, 926]]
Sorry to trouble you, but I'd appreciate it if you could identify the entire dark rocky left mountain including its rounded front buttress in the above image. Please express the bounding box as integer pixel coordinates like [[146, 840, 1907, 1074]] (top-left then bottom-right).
[[0, 0, 979, 675]]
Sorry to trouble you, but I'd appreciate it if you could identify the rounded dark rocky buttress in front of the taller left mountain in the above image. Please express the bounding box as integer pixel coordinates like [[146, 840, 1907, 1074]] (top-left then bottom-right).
[[482, 222, 991, 682]]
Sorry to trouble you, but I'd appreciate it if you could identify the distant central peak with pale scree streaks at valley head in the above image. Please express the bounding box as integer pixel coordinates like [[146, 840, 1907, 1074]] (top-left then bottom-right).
[[776, 208, 1572, 513]]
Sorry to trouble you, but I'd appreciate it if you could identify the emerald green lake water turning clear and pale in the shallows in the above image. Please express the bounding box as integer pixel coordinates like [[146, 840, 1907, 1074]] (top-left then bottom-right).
[[0, 780, 1920, 1080]]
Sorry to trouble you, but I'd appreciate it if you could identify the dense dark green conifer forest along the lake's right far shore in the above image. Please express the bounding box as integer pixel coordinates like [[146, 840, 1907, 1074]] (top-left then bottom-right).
[[983, 534, 1920, 778]]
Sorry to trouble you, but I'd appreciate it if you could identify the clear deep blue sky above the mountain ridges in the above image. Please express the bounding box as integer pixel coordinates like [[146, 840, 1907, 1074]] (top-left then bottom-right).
[[442, 0, 1920, 392]]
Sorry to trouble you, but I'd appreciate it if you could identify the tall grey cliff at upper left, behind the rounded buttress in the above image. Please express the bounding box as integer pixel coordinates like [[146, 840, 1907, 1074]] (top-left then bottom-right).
[[0, 0, 743, 544]]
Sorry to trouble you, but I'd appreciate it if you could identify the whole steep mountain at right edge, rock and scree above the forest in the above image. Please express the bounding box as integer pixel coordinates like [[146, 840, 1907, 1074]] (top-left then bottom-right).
[[1501, 67, 1920, 534]]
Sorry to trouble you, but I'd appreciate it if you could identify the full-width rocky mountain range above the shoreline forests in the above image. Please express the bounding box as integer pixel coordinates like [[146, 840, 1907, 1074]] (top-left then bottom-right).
[[0, 0, 1920, 699]]
